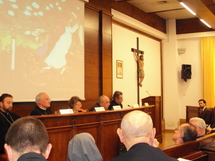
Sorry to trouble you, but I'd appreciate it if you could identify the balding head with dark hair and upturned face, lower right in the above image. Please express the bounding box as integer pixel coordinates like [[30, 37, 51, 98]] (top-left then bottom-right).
[[172, 123, 197, 144]]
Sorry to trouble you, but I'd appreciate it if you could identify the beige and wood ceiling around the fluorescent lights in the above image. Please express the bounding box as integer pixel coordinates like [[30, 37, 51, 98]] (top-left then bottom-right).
[[120, 0, 215, 29]]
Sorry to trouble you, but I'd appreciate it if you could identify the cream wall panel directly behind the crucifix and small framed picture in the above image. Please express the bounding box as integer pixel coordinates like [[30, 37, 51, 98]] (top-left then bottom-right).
[[112, 24, 161, 108]]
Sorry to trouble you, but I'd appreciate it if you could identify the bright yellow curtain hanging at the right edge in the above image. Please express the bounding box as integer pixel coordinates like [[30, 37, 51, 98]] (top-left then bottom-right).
[[201, 36, 215, 107]]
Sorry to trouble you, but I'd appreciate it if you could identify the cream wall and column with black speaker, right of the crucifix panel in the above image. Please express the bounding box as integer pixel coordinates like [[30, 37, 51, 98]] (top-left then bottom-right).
[[162, 20, 210, 129]]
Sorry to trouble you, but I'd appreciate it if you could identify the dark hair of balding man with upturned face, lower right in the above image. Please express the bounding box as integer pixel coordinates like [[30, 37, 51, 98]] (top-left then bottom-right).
[[181, 123, 197, 142]]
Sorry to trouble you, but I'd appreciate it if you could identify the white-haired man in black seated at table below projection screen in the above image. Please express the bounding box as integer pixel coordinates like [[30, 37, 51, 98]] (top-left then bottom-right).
[[30, 92, 52, 115]]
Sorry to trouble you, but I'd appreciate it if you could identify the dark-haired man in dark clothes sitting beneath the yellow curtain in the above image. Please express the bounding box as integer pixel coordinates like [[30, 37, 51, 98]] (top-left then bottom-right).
[[198, 99, 213, 125]]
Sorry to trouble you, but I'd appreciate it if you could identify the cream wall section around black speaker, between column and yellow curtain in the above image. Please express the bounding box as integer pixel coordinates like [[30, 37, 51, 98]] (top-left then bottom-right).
[[177, 38, 202, 118]]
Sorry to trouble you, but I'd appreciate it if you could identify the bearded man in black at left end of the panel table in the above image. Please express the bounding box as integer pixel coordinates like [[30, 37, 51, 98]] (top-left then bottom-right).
[[0, 93, 19, 154]]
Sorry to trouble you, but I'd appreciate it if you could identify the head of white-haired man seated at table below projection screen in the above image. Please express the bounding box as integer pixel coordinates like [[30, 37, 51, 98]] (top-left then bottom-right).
[[35, 92, 51, 110]]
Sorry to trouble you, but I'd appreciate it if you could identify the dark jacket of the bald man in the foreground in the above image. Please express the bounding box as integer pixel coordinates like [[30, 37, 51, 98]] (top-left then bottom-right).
[[110, 143, 177, 161]]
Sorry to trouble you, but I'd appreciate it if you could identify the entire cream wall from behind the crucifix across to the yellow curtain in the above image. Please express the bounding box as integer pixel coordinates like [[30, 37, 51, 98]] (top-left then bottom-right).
[[113, 11, 215, 129]]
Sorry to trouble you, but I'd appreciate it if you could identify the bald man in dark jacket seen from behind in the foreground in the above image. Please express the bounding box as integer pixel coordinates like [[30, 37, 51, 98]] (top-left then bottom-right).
[[111, 110, 176, 161]]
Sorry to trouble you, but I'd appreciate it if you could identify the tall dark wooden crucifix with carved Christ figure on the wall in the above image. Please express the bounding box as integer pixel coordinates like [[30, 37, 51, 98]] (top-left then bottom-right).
[[131, 37, 144, 105]]
